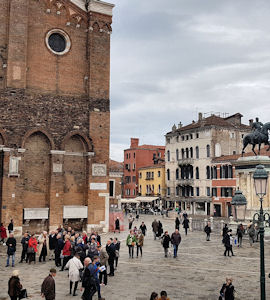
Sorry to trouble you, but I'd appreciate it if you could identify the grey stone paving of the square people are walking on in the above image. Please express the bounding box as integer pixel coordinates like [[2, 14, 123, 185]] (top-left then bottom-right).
[[0, 216, 270, 300]]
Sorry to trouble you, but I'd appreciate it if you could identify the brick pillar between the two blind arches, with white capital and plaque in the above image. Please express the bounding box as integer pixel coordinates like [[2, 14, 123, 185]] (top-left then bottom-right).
[[49, 150, 65, 230]]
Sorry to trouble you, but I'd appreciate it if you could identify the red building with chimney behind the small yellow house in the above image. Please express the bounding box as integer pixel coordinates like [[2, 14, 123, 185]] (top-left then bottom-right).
[[123, 138, 165, 198]]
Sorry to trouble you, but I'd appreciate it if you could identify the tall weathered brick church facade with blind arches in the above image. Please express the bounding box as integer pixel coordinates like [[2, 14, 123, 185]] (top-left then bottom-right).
[[0, 0, 113, 233]]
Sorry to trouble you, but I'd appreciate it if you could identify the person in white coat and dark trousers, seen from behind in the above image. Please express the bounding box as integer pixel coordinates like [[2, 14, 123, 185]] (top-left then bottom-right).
[[66, 253, 83, 296]]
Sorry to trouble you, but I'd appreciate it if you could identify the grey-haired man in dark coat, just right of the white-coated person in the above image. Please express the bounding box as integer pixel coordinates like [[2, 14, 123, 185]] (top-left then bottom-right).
[[81, 257, 97, 300]]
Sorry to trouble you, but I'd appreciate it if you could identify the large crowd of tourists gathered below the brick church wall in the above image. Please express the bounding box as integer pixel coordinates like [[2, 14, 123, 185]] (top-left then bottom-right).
[[1, 220, 122, 300]]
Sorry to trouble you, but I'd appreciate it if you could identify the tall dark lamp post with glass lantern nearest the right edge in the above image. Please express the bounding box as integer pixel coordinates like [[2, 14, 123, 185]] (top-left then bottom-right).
[[253, 165, 269, 300]]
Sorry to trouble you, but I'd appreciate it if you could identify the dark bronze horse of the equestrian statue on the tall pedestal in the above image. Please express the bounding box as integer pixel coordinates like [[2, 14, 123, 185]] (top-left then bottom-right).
[[242, 122, 270, 156]]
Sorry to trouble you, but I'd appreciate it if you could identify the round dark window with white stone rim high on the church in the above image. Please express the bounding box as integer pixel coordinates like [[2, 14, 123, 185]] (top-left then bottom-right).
[[46, 29, 71, 55]]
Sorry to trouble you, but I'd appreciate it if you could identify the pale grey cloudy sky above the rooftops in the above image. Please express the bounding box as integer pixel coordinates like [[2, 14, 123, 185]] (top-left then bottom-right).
[[108, 0, 270, 161]]
